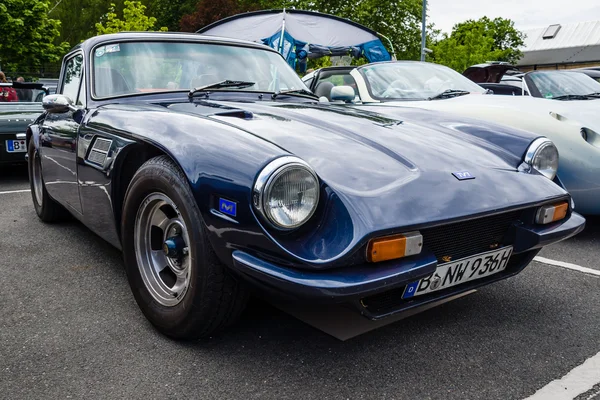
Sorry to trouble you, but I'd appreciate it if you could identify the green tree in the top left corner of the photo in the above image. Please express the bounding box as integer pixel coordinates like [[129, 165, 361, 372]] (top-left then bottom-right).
[[0, 0, 69, 74]]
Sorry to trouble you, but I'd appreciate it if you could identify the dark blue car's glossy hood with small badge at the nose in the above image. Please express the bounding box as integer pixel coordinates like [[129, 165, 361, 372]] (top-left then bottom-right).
[[166, 101, 565, 230]]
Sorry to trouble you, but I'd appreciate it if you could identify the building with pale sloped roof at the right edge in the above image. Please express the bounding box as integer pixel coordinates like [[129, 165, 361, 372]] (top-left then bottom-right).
[[517, 21, 600, 71]]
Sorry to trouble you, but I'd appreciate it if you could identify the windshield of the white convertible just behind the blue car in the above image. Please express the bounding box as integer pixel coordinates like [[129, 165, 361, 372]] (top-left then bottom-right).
[[359, 62, 485, 100]]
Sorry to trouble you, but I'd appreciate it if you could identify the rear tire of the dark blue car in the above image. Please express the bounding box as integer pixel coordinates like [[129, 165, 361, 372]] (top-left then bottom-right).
[[27, 139, 68, 222]]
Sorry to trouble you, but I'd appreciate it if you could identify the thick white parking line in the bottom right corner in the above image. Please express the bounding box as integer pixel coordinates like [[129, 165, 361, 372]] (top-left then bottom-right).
[[525, 353, 600, 400]]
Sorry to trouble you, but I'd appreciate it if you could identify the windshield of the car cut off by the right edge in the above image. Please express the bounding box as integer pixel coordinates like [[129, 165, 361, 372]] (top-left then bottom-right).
[[527, 71, 600, 99]]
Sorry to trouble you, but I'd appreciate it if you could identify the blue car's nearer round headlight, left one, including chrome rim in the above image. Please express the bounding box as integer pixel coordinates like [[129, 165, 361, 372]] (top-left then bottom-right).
[[254, 157, 319, 229]]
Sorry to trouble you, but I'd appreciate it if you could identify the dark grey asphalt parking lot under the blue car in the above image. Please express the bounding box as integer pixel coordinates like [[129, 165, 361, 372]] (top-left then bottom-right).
[[0, 167, 600, 400]]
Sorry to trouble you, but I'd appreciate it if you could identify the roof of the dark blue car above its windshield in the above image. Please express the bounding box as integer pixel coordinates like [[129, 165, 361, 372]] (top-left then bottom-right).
[[71, 32, 277, 52]]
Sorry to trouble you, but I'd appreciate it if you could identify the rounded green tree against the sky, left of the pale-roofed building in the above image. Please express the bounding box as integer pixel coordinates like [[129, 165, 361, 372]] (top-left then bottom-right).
[[430, 17, 525, 72]]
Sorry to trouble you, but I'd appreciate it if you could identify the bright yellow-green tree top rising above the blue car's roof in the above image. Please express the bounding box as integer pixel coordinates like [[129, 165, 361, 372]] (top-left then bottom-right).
[[96, 0, 167, 35]]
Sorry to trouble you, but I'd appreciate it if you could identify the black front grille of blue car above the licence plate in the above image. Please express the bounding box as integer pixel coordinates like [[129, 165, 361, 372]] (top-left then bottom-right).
[[420, 211, 523, 263]]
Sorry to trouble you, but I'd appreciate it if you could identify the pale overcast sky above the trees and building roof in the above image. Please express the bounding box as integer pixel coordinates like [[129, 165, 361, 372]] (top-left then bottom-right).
[[427, 0, 600, 33]]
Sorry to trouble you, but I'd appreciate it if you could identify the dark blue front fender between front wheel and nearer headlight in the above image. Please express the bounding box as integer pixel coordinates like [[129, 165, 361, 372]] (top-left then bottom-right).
[[84, 105, 289, 264]]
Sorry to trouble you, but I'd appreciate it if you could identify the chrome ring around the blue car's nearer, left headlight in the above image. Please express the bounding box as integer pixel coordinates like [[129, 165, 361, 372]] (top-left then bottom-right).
[[252, 156, 320, 231]]
